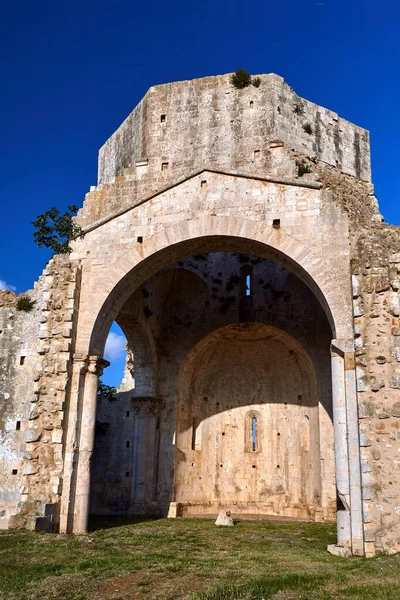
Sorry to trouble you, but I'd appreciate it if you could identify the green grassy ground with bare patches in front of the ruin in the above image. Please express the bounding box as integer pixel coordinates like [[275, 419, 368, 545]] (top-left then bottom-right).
[[0, 519, 400, 600]]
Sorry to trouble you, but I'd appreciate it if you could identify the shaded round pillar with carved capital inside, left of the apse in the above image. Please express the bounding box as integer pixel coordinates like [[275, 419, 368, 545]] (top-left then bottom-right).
[[131, 397, 161, 514]]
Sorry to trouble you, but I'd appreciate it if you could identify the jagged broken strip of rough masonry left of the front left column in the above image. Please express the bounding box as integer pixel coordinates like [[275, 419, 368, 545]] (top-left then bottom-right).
[[9, 256, 81, 530]]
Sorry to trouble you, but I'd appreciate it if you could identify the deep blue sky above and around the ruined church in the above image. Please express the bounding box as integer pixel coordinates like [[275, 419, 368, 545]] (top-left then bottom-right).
[[0, 0, 400, 384]]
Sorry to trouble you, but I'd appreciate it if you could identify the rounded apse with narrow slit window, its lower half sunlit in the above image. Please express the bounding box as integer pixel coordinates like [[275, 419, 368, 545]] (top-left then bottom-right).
[[174, 323, 336, 520]]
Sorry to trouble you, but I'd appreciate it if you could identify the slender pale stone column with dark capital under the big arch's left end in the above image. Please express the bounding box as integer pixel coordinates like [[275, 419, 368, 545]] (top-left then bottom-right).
[[73, 356, 110, 533]]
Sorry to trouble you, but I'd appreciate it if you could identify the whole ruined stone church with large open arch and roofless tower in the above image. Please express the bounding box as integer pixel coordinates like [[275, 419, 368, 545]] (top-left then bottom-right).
[[0, 74, 400, 556]]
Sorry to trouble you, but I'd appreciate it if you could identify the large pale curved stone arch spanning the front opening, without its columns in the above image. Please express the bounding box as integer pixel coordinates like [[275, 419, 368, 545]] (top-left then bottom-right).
[[77, 215, 351, 355]]
